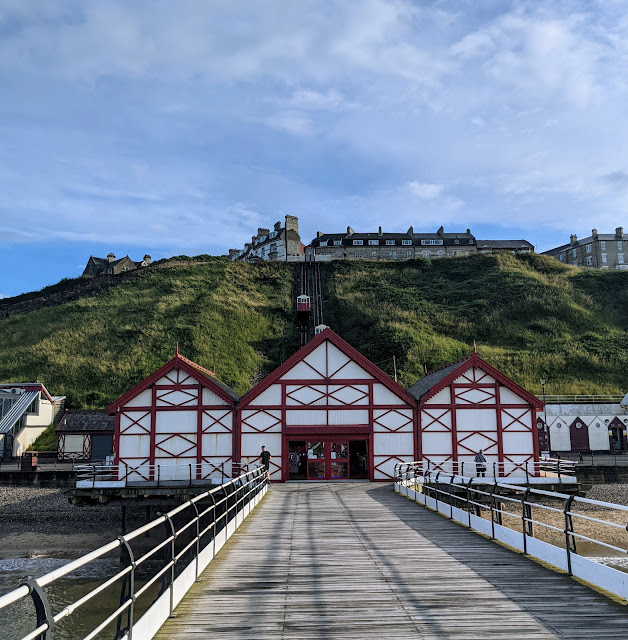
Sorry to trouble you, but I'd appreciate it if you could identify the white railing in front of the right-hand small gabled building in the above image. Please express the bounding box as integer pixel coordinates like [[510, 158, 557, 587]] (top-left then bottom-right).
[[398, 458, 577, 482]]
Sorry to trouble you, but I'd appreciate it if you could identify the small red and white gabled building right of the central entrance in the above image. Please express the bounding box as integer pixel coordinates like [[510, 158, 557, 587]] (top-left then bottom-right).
[[408, 351, 543, 475]]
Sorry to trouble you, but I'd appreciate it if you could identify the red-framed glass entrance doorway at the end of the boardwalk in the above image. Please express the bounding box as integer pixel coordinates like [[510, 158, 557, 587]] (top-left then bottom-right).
[[284, 436, 369, 480]]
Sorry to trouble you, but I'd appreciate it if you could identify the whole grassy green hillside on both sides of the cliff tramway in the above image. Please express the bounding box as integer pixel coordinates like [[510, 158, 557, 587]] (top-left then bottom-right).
[[0, 255, 628, 407]]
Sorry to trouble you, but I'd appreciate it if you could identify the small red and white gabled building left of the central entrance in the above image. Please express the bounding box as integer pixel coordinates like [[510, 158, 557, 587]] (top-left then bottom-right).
[[107, 350, 239, 481]]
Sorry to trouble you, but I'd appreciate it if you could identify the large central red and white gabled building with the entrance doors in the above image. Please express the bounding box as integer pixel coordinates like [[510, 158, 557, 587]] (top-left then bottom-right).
[[237, 328, 417, 481]]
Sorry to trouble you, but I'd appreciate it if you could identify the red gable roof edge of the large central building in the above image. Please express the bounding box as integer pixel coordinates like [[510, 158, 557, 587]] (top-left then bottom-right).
[[240, 327, 416, 405]]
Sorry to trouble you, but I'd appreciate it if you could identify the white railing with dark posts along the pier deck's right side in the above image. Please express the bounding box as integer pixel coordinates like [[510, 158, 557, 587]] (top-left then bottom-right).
[[395, 464, 628, 599]]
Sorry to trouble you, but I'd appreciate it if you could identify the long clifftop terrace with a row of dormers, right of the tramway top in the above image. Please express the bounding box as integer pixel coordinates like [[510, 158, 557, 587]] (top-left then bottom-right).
[[307, 227, 534, 260]]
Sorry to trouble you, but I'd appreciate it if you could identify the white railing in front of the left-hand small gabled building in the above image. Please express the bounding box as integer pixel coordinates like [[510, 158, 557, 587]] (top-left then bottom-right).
[[74, 462, 248, 488]]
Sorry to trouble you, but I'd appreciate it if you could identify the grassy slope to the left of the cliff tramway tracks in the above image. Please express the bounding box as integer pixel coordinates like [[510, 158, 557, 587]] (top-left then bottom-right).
[[0, 258, 295, 407]]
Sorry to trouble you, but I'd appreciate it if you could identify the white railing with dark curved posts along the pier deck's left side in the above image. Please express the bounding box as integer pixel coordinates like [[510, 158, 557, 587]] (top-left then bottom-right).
[[0, 467, 267, 640]]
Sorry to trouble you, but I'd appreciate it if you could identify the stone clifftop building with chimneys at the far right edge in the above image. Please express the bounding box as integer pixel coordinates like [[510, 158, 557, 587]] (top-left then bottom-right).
[[543, 227, 628, 269]]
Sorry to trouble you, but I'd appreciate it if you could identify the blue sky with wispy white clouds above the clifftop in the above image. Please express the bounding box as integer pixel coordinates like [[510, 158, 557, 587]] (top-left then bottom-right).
[[0, 0, 628, 296]]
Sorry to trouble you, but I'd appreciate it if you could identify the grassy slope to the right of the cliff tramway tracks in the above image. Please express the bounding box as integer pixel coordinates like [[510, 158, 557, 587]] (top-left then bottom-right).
[[325, 255, 628, 394]]
